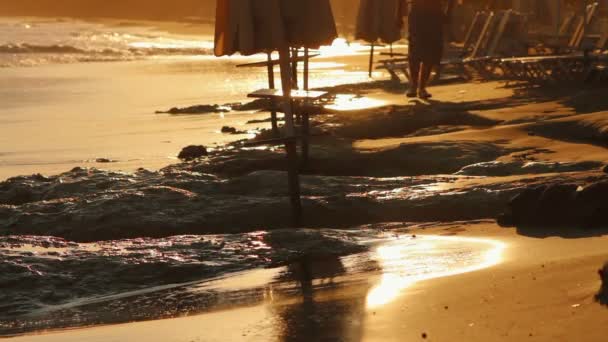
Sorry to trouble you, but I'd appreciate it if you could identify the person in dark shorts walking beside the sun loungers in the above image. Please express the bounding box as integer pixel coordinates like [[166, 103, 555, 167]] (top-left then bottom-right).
[[406, 0, 454, 99]]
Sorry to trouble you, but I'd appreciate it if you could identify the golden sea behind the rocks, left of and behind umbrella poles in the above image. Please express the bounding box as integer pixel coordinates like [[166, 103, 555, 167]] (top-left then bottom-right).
[[0, 18, 380, 179]]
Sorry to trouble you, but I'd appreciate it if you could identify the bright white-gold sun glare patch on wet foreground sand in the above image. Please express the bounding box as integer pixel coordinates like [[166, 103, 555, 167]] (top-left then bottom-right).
[[366, 236, 506, 309]]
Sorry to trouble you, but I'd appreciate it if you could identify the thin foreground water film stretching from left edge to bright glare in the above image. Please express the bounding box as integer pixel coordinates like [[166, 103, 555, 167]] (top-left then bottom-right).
[[0, 231, 505, 334]]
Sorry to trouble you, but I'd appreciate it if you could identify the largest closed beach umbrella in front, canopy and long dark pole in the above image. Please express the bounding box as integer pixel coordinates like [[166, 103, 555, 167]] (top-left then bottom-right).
[[214, 0, 337, 221]]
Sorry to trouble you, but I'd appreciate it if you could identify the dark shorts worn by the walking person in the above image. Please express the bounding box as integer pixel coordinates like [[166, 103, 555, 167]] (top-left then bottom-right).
[[409, 11, 445, 66]]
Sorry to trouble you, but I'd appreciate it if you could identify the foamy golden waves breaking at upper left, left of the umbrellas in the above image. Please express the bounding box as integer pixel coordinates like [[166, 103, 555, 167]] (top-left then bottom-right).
[[0, 18, 213, 67]]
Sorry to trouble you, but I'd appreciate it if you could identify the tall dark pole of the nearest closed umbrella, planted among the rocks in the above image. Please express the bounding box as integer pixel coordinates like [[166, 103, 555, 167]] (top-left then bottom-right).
[[279, 46, 302, 226]]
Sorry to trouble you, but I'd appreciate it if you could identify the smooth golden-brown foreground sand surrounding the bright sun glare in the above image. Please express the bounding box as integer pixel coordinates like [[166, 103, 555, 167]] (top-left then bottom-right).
[[14, 222, 608, 342]]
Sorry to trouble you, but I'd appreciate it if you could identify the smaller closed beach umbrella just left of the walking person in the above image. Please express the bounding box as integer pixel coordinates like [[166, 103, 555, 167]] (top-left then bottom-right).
[[355, 0, 407, 44]]
